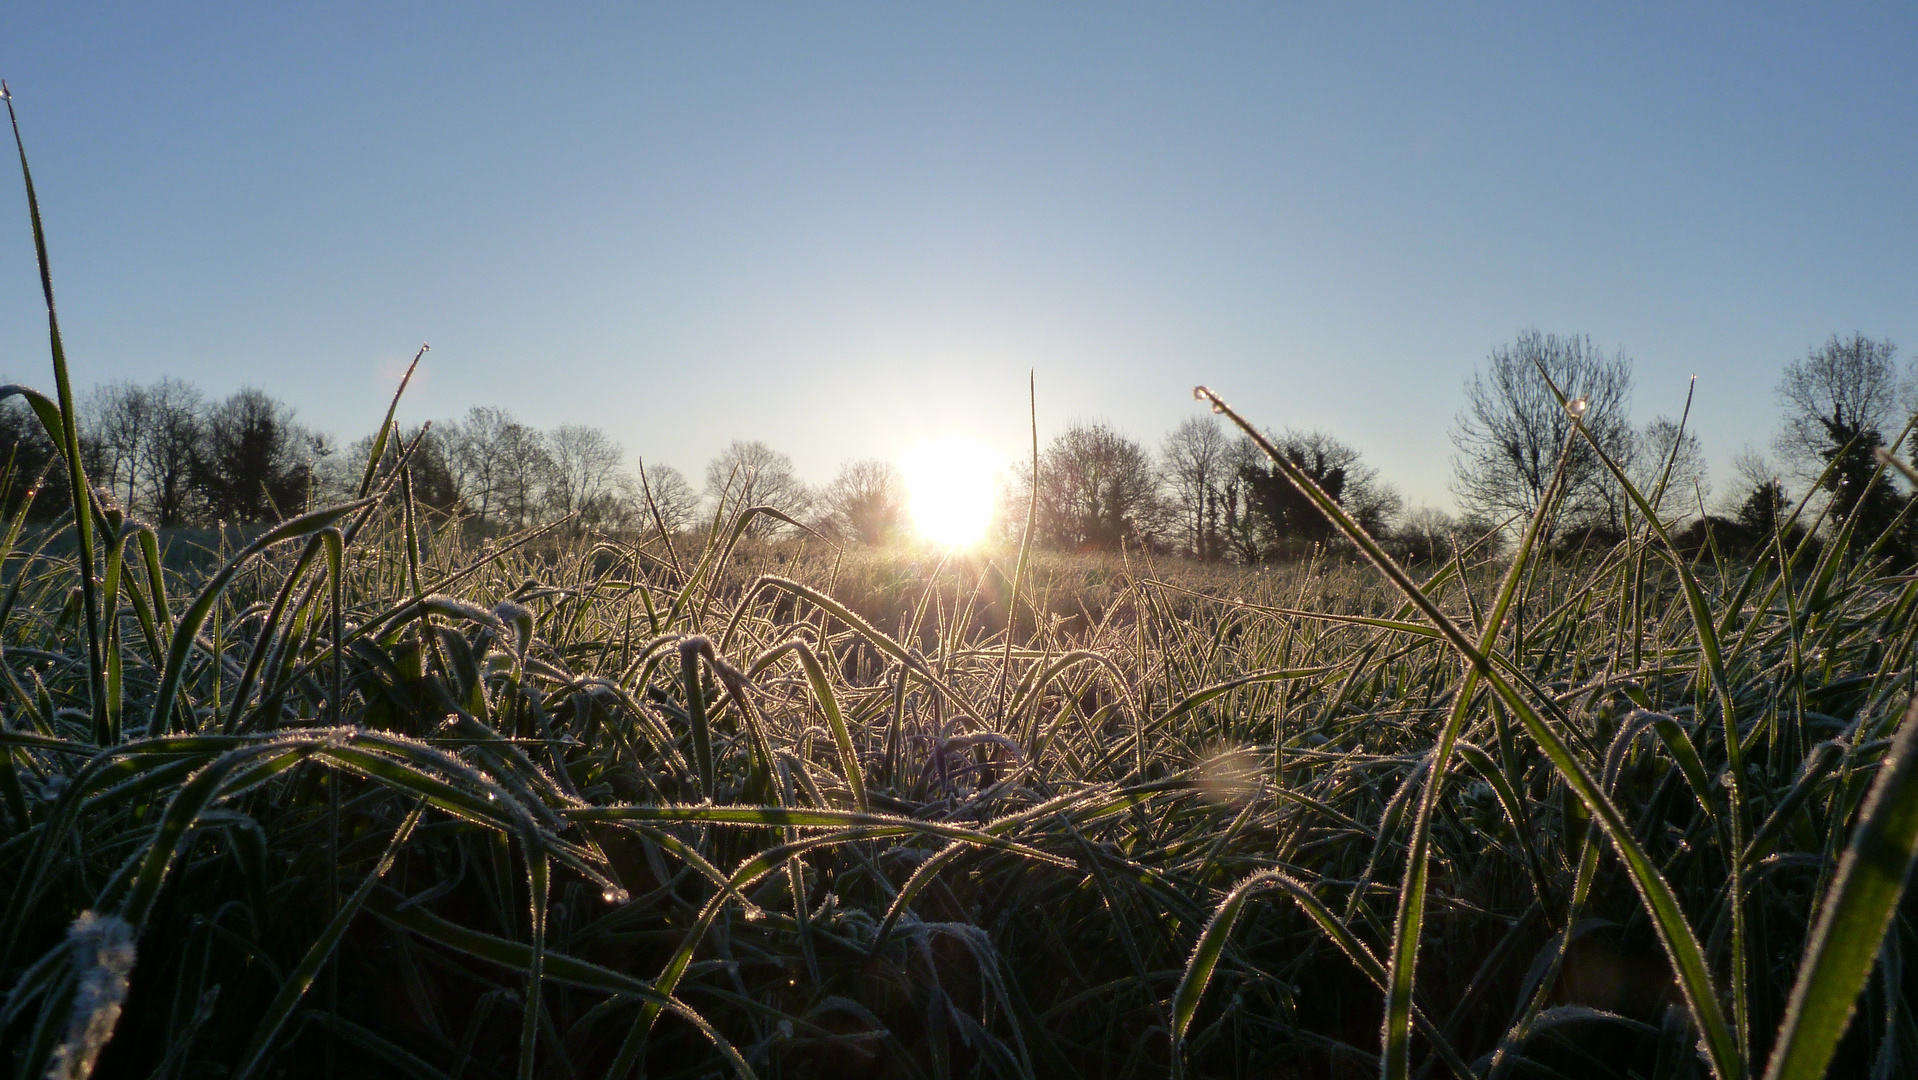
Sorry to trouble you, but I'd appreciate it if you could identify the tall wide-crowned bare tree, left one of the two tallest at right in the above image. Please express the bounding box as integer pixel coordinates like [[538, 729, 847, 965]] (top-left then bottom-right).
[[1452, 330, 1634, 524]]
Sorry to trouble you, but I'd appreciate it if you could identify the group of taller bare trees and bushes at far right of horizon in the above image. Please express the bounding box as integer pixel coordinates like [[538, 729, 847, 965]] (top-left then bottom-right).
[[1452, 330, 1918, 566]]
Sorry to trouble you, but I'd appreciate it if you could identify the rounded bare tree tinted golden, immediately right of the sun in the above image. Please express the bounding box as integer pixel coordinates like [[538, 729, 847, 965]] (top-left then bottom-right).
[[1024, 424, 1158, 551]]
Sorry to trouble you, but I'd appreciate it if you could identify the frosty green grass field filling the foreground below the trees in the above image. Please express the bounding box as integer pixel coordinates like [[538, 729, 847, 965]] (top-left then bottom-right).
[[0, 93, 1918, 1078]]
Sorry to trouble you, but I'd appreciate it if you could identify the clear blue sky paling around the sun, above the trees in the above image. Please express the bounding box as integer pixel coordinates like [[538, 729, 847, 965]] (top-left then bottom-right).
[[0, 4, 1918, 505]]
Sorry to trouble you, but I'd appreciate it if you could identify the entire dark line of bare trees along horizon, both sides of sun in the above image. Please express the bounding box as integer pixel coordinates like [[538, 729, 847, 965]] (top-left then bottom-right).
[[18, 330, 1918, 564]]
